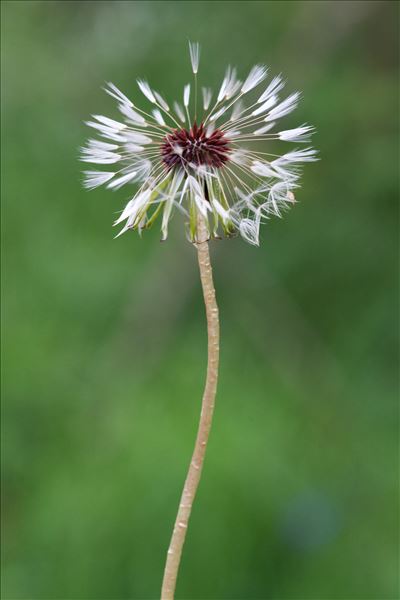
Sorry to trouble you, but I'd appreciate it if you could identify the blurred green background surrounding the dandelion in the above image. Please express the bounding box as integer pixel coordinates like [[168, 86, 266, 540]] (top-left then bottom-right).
[[2, 1, 399, 600]]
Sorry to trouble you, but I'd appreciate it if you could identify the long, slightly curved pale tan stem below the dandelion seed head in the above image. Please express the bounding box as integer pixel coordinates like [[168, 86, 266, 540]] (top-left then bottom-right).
[[161, 218, 219, 600]]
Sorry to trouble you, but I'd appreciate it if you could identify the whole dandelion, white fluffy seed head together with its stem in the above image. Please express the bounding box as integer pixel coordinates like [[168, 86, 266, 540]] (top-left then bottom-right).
[[81, 43, 317, 600]]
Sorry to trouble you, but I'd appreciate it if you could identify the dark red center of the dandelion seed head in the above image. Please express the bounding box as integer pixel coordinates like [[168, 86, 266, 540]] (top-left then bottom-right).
[[161, 122, 231, 169]]
